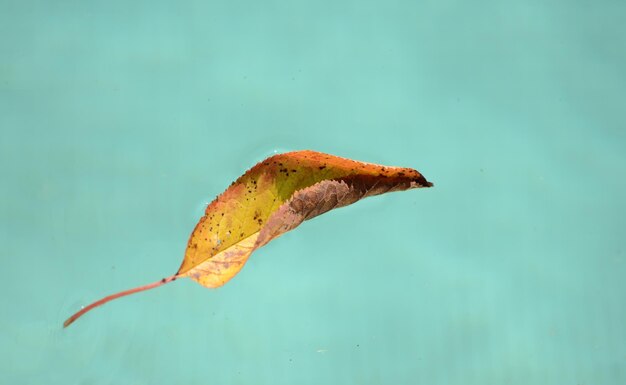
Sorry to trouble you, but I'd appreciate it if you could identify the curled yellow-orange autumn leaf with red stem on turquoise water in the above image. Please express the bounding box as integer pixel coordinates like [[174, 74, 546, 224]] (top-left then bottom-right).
[[63, 150, 432, 327]]
